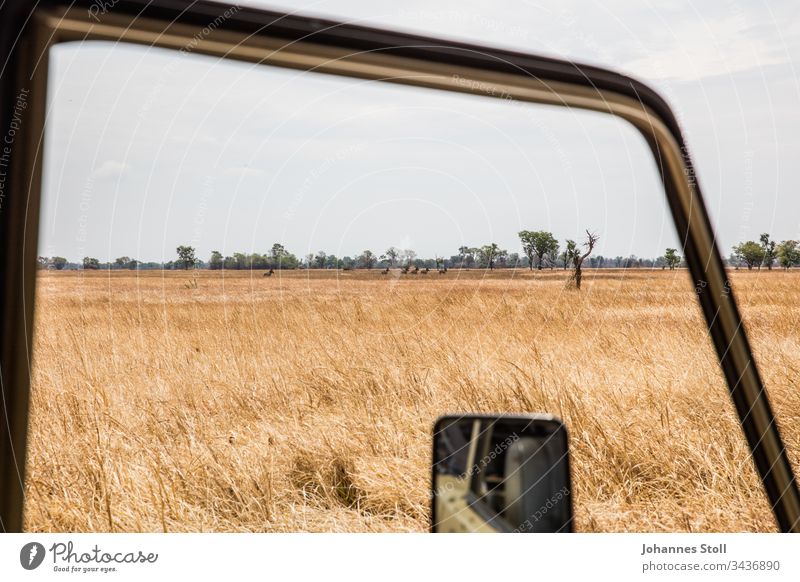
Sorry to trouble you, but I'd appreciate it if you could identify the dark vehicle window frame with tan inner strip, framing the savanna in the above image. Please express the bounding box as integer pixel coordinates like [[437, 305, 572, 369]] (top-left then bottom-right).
[[0, 0, 800, 532]]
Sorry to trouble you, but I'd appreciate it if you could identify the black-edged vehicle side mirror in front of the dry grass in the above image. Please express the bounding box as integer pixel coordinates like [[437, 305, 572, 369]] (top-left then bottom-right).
[[432, 415, 572, 533]]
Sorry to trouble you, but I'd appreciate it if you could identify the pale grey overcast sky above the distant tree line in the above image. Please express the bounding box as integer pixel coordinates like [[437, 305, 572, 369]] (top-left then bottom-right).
[[40, 0, 800, 260]]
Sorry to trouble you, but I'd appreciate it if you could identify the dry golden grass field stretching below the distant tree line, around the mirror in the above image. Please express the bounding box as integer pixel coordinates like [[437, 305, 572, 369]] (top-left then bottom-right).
[[21, 270, 800, 532]]
